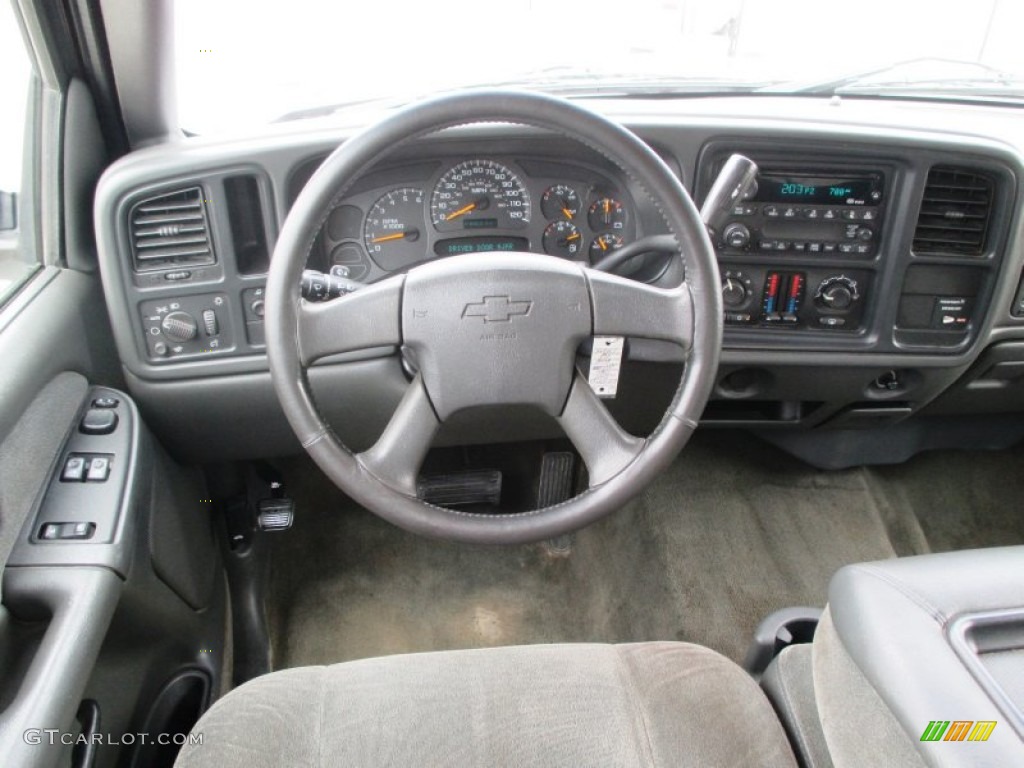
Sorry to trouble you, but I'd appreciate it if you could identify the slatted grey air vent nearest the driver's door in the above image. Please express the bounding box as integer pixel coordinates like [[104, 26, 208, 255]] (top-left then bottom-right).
[[131, 186, 215, 272]]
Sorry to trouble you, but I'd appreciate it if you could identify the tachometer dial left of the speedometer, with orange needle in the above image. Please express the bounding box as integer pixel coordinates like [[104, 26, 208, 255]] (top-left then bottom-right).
[[362, 186, 429, 272]]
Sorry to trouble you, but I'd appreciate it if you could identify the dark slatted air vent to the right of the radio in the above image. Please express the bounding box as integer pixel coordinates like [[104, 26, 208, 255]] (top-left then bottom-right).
[[913, 166, 993, 256]]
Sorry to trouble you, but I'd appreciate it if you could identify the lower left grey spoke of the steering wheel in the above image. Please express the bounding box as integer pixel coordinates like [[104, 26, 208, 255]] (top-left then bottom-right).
[[355, 376, 440, 497]]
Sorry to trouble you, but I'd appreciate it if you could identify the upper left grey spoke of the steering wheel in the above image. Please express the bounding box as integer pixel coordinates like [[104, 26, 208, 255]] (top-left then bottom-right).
[[298, 275, 404, 366]]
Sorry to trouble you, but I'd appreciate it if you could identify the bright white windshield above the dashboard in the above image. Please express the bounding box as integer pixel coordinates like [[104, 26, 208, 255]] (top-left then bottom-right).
[[175, 0, 1024, 133]]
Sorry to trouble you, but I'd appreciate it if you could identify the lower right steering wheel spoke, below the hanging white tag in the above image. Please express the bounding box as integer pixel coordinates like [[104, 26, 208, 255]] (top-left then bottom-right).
[[558, 372, 646, 487]]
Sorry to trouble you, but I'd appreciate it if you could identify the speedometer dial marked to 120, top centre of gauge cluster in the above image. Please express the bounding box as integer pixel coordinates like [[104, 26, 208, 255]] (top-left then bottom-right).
[[430, 160, 530, 231]]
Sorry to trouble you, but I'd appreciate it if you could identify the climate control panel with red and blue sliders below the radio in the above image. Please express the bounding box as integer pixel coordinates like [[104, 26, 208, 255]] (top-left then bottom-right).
[[721, 264, 870, 331]]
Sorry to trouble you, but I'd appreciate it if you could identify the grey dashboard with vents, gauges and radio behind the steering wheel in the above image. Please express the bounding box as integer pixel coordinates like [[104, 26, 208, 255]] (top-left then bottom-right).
[[95, 98, 1024, 465]]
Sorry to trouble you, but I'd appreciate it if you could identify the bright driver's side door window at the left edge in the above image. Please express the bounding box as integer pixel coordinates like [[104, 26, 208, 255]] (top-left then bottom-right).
[[0, 2, 39, 304]]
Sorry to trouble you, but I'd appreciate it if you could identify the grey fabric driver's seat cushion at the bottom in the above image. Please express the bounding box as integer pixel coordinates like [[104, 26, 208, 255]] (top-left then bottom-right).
[[176, 643, 796, 768]]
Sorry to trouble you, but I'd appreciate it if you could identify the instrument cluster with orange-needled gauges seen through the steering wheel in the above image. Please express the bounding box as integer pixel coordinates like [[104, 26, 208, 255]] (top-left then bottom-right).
[[322, 157, 637, 282]]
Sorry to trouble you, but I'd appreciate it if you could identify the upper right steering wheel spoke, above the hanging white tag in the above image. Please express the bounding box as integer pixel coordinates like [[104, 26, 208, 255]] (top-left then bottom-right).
[[587, 269, 693, 349]]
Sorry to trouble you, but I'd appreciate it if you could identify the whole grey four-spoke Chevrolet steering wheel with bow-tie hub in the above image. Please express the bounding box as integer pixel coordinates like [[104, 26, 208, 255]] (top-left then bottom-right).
[[265, 90, 722, 544]]
